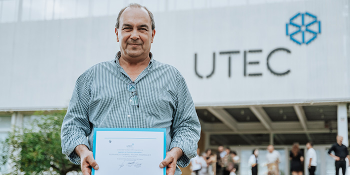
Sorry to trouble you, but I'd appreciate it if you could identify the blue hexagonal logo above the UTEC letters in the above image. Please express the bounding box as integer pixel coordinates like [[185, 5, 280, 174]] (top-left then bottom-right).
[[286, 12, 321, 45]]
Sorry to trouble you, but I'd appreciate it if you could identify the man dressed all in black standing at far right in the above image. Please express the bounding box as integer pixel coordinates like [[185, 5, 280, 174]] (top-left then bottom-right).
[[328, 135, 350, 175]]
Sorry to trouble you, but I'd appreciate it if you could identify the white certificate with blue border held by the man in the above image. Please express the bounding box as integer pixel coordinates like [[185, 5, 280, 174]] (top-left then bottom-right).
[[92, 128, 166, 175]]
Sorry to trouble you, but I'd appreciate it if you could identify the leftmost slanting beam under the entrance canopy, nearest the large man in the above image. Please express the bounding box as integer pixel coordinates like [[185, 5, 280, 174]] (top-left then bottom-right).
[[207, 107, 237, 131]]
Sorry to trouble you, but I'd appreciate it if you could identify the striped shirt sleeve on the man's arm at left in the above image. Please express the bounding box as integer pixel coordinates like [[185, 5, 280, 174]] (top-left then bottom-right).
[[61, 70, 92, 164]]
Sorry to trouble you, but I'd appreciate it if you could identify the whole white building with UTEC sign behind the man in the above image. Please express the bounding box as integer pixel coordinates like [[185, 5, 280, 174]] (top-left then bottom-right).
[[0, 0, 350, 175]]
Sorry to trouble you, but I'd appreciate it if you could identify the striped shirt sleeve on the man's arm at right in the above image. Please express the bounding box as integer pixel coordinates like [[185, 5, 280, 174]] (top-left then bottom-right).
[[170, 73, 201, 167]]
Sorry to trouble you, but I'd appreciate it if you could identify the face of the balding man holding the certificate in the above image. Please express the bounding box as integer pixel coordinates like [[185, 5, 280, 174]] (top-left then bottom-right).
[[115, 7, 156, 57]]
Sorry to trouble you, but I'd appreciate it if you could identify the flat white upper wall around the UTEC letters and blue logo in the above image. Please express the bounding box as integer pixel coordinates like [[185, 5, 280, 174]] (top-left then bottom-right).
[[0, 0, 350, 110]]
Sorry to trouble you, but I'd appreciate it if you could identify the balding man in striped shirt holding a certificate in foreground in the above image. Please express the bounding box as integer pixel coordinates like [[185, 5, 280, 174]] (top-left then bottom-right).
[[61, 4, 200, 175]]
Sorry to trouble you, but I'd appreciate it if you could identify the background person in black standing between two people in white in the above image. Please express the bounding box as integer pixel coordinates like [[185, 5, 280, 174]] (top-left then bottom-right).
[[289, 143, 304, 175]]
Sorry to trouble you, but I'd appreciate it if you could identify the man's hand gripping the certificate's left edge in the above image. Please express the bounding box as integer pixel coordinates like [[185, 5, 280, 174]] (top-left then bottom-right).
[[75, 145, 99, 175]]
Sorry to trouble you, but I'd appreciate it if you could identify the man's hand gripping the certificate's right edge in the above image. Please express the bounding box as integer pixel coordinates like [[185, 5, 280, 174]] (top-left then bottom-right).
[[159, 147, 183, 175]]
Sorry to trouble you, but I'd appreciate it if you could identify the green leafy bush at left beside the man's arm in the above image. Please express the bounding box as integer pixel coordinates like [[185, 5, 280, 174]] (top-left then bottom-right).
[[0, 111, 80, 175]]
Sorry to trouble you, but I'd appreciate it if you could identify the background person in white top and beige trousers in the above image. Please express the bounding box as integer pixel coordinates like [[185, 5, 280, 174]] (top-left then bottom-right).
[[266, 145, 281, 175]]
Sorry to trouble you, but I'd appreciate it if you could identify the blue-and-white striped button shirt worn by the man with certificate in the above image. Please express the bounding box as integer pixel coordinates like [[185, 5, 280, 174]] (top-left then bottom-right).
[[61, 52, 201, 174]]
